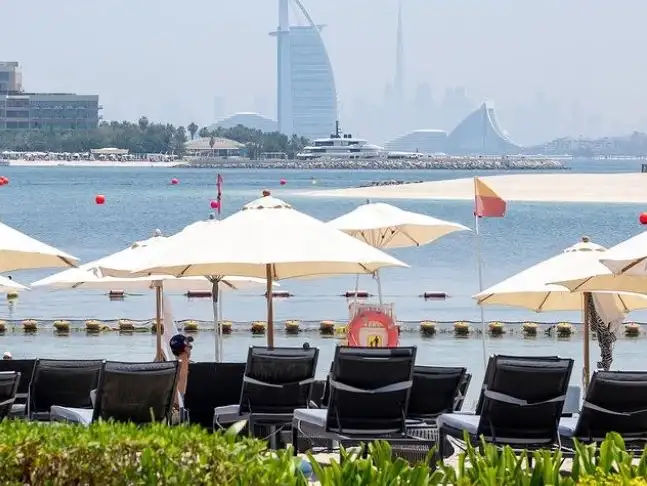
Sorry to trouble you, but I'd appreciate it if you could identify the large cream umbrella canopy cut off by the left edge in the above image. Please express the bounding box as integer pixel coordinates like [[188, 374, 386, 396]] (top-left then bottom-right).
[[0, 223, 78, 272]]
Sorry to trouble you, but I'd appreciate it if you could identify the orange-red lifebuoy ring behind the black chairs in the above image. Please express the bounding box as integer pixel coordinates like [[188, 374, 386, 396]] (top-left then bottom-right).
[[346, 310, 399, 348]]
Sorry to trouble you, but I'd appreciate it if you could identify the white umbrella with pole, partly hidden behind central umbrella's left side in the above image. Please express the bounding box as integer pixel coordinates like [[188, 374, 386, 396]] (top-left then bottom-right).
[[32, 230, 265, 357]]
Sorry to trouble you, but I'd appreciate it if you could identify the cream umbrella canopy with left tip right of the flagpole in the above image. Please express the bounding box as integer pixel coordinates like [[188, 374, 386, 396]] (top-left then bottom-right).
[[474, 241, 647, 312]]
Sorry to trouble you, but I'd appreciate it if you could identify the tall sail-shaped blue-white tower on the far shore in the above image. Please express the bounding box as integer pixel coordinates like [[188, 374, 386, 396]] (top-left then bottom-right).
[[271, 0, 337, 139]]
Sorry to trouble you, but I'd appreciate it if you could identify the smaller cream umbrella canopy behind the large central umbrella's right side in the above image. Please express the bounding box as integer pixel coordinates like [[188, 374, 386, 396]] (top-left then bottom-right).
[[328, 203, 469, 249]]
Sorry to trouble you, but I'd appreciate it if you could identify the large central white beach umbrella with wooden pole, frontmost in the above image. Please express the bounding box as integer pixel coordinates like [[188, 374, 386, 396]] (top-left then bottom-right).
[[127, 195, 408, 346]]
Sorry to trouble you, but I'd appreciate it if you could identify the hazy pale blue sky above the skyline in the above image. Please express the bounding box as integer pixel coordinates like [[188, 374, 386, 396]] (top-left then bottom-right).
[[0, 0, 647, 142]]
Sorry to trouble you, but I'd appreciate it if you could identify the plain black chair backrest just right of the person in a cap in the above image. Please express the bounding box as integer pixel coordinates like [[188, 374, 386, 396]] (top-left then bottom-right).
[[189, 363, 246, 429]]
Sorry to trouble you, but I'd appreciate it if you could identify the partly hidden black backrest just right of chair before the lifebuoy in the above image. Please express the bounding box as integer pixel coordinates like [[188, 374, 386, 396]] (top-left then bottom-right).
[[407, 366, 467, 420]]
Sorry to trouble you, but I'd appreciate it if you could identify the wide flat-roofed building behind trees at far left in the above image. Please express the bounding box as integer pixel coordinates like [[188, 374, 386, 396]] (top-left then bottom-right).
[[0, 62, 101, 131]]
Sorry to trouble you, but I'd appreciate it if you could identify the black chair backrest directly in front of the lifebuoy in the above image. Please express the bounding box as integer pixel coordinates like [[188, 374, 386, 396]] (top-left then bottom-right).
[[326, 346, 416, 435]]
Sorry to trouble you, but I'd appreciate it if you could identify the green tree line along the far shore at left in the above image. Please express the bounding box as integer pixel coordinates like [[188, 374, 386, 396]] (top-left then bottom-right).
[[0, 116, 308, 159]]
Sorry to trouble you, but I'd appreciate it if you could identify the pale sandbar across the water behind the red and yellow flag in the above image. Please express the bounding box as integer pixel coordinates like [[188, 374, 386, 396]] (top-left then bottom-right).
[[304, 173, 647, 204]]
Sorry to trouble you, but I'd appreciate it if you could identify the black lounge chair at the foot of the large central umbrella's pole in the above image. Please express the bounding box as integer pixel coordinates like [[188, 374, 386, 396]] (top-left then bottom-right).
[[213, 346, 319, 441]]
